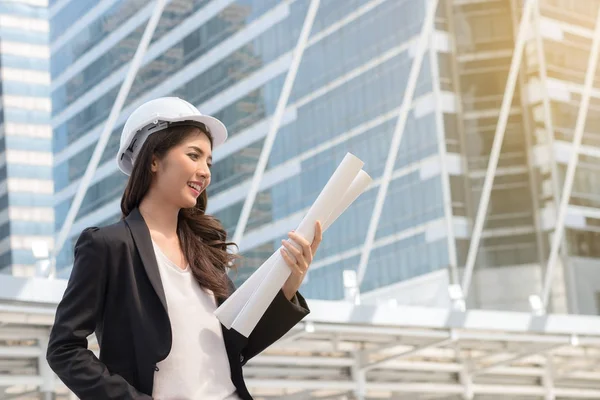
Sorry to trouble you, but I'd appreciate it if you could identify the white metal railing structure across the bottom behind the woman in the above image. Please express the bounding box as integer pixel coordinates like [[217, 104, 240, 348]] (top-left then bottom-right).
[[0, 277, 600, 400]]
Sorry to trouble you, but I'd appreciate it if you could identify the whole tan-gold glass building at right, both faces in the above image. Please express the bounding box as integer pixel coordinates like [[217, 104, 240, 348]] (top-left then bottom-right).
[[453, 0, 600, 313]]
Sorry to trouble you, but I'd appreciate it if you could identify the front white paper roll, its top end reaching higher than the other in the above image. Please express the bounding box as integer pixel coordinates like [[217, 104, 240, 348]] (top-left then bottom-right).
[[221, 153, 364, 337]]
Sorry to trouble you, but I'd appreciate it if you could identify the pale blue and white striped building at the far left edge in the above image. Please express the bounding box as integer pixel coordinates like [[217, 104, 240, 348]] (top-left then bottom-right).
[[0, 0, 54, 276]]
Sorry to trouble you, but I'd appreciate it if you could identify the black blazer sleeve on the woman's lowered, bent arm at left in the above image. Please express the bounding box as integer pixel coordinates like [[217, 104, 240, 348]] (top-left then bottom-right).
[[46, 228, 151, 399]]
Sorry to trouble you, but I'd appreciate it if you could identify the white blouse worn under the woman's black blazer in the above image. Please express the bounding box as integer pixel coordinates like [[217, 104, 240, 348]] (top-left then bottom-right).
[[152, 242, 239, 400]]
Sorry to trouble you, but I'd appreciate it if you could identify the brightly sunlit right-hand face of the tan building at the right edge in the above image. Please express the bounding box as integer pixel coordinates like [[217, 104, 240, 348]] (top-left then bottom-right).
[[527, 0, 600, 300]]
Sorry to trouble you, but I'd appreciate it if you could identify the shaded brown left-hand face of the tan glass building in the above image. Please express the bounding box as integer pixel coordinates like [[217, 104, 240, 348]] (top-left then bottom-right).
[[454, 1, 538, 267]]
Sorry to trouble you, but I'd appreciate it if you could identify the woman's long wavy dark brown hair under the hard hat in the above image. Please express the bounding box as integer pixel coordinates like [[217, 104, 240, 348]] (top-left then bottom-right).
[[121, 124, 238, 298]]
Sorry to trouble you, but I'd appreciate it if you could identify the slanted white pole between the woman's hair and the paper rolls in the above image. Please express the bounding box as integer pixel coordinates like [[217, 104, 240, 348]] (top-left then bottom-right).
[[233, 0, 320, 245]]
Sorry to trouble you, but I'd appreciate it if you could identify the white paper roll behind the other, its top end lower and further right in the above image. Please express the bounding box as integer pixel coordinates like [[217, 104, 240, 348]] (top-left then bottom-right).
[[215, 170, 373, 329]]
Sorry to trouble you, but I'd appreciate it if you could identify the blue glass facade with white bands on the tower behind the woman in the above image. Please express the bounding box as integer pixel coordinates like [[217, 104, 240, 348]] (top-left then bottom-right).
[[50, 0, 451, 299]]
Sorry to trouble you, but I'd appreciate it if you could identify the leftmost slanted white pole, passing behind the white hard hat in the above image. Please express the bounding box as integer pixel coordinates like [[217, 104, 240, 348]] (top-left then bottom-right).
[[52, 0, 166, 260]]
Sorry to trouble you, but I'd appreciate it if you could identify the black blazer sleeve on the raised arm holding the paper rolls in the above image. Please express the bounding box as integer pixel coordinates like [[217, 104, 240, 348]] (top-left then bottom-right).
[[241, 289, 310, 365]]
